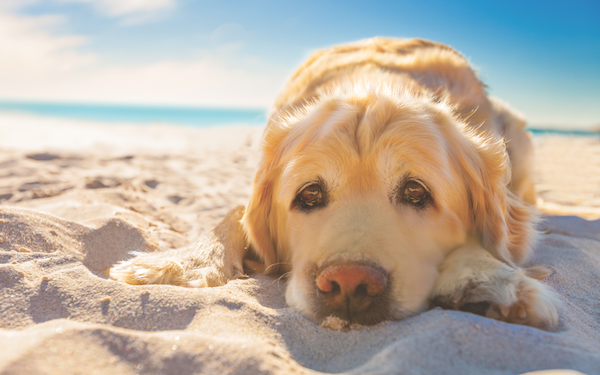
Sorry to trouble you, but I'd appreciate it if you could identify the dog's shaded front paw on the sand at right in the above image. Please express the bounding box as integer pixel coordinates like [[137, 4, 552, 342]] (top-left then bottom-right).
[[485, 276, 559, 328]]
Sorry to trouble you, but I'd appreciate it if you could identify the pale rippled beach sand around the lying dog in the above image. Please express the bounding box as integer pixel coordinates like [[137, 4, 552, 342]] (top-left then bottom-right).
[[0, 115, 600, 374]]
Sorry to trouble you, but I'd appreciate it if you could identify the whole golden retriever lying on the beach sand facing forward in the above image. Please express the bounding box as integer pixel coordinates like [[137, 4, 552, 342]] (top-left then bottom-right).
[[109, 37, 558, 328]]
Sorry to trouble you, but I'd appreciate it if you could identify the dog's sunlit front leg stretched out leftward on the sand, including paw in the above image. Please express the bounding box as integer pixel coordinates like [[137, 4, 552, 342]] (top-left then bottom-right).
[[108, 206, 247, 288]]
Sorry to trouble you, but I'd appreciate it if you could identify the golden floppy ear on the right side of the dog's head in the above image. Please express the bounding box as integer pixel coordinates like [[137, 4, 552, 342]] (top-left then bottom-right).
[[464, 134, 536, 264]]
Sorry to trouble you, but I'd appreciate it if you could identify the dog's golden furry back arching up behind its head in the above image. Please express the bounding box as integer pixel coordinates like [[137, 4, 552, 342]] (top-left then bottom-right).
[[274, 38, 491, 122]]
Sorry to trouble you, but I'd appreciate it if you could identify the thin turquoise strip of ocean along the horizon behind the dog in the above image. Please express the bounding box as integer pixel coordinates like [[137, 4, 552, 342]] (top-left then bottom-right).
[[0, 102, 600, 136]]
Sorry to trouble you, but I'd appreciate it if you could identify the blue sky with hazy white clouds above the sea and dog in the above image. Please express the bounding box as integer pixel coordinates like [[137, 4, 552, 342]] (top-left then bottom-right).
[[0, 0, 600, 129]]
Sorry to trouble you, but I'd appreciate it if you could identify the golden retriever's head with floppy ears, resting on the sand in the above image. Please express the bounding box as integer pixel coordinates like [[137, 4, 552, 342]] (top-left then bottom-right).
[[242, 87, 533, 324]]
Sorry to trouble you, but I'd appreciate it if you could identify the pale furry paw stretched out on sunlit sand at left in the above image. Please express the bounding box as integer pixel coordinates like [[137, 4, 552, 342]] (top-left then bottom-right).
[[107, 256, 185, 285]]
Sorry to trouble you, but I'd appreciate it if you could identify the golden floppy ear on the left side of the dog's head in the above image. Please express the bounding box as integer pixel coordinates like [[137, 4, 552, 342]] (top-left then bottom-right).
[[242, 167, 278, 272]]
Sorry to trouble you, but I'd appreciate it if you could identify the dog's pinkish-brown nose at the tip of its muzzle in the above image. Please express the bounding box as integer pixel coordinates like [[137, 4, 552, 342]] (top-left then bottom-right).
[[315, 262, 388, 324]]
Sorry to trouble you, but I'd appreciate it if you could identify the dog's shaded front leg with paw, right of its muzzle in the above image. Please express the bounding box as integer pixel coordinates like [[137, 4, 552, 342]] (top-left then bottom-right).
[[431, 243, 559, 328]]
